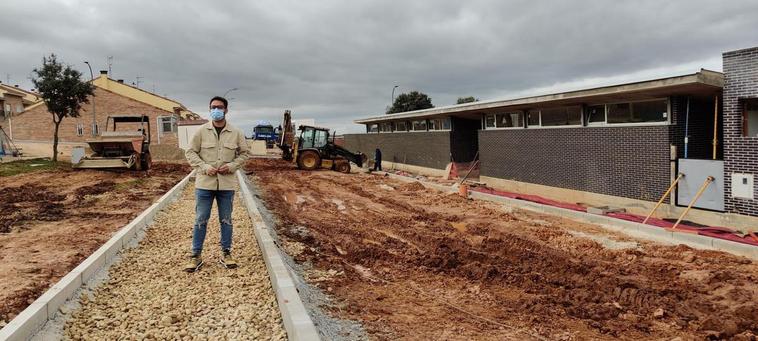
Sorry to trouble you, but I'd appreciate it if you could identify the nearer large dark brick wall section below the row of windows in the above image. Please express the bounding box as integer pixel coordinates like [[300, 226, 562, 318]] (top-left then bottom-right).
[[479, 126, 670, 201]]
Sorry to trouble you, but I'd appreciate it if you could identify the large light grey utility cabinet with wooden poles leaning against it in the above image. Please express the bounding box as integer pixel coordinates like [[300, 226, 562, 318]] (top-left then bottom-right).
[[676, 159, 724, 211]]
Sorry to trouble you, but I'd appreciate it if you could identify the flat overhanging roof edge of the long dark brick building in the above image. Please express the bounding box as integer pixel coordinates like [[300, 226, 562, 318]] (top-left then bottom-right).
[[354, 69, 724, 124]]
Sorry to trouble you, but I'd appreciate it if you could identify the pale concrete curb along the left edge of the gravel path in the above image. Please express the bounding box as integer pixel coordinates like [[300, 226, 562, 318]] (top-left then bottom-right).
[[0, 171, 195, 341]]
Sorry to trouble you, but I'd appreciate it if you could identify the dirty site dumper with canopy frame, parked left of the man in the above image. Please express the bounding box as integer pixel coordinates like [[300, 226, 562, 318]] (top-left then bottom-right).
[[71, 115, 152, 170]]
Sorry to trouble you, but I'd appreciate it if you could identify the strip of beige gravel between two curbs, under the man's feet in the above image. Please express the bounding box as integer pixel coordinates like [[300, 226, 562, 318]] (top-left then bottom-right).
[[64, 184, 286, 340]]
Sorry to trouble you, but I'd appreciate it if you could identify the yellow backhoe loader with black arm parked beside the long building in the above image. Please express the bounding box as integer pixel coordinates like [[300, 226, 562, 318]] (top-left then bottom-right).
[[277, 110, 366, 173]]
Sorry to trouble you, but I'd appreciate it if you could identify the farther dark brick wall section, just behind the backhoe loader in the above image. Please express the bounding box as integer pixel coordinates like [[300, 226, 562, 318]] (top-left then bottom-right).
[[345, 131, 450, 169]]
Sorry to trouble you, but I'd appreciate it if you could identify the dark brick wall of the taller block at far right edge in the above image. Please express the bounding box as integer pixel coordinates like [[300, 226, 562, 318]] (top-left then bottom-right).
[[723, 47, 758, 216]]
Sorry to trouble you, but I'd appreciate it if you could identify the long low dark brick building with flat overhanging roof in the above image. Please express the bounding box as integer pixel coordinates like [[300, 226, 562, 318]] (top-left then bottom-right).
[[345, 48, 758, 226]]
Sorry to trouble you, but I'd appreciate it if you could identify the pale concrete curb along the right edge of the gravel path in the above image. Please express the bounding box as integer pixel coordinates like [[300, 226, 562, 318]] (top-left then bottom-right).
[[237, 171, 320, 341]]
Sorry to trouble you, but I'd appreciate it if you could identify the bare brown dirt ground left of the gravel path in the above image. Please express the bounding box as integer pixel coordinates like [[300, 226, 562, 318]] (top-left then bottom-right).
[[0, 164, 190, 323]]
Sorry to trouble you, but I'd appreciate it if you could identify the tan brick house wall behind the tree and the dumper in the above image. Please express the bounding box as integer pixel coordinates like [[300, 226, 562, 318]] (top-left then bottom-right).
[[13, 88, 177, 144]]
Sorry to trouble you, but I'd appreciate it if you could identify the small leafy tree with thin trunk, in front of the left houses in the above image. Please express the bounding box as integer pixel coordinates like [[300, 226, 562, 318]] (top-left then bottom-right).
[[32, 54, 95, 161]]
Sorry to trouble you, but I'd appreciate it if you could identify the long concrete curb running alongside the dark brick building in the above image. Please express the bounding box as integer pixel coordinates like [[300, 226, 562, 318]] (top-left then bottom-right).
[[387, 173, 758, 260]]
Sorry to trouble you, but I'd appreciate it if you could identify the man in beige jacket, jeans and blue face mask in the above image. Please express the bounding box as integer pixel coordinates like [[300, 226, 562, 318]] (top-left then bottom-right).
[[184, 96, 250, 272]]
